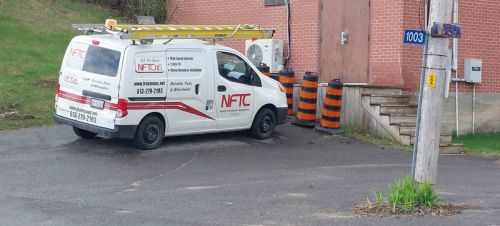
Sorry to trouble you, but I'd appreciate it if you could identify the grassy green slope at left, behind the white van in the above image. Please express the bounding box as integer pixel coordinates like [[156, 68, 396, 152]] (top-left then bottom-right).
[[0, 0, 117, 130]]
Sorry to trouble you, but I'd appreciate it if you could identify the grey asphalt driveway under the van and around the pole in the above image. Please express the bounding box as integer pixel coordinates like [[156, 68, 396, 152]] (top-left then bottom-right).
[[0, 125, 500, 225]]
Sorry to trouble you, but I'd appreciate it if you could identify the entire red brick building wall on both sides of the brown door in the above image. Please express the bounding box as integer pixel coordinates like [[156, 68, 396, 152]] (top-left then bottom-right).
[[168, 0, 500, 93]]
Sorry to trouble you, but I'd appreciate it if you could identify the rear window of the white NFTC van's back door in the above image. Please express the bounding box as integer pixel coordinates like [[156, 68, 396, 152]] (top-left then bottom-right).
[[82, 46, 121, 77]]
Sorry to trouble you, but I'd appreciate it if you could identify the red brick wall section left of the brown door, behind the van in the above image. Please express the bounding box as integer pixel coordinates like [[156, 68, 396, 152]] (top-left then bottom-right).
[[168, 0, 319, 77]]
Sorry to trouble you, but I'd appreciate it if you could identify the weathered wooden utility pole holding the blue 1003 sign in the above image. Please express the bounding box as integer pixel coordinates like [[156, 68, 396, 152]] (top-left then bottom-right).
[[415, 0, 453, 184]]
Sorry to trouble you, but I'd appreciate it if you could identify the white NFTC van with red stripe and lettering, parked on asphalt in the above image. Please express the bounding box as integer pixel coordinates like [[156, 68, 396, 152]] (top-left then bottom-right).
[[54, 35, 287, 149]]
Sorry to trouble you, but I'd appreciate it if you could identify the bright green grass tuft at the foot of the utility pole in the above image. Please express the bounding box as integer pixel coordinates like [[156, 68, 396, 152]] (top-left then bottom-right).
[[374, 176, 439, 213]]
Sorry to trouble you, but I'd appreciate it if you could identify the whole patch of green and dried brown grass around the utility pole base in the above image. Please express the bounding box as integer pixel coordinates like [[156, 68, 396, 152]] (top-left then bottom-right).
[[355, 176, 462, 216]]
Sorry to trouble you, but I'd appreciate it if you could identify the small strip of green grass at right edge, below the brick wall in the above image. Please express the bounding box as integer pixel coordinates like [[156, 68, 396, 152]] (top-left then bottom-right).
[[453, 133, 500, 158]]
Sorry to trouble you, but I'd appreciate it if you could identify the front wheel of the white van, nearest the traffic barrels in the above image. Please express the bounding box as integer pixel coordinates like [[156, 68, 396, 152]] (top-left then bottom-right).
[[250, 108, 276, 140]]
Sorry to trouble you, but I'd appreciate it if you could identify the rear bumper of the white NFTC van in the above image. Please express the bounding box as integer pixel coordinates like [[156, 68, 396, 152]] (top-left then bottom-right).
[[54, 114, 137, 139]]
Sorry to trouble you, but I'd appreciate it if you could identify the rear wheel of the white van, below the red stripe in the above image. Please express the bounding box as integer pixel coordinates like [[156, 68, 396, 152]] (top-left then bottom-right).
[[134, 115, 165, 150]]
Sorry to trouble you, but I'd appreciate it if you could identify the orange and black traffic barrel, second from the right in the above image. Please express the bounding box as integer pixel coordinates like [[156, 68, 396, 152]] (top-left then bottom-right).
[[291, 72, 319, 127]]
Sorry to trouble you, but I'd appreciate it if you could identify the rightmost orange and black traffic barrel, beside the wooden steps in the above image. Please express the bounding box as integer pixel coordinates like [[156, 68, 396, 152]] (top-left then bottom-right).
[[315, 79, 344, 135]]
